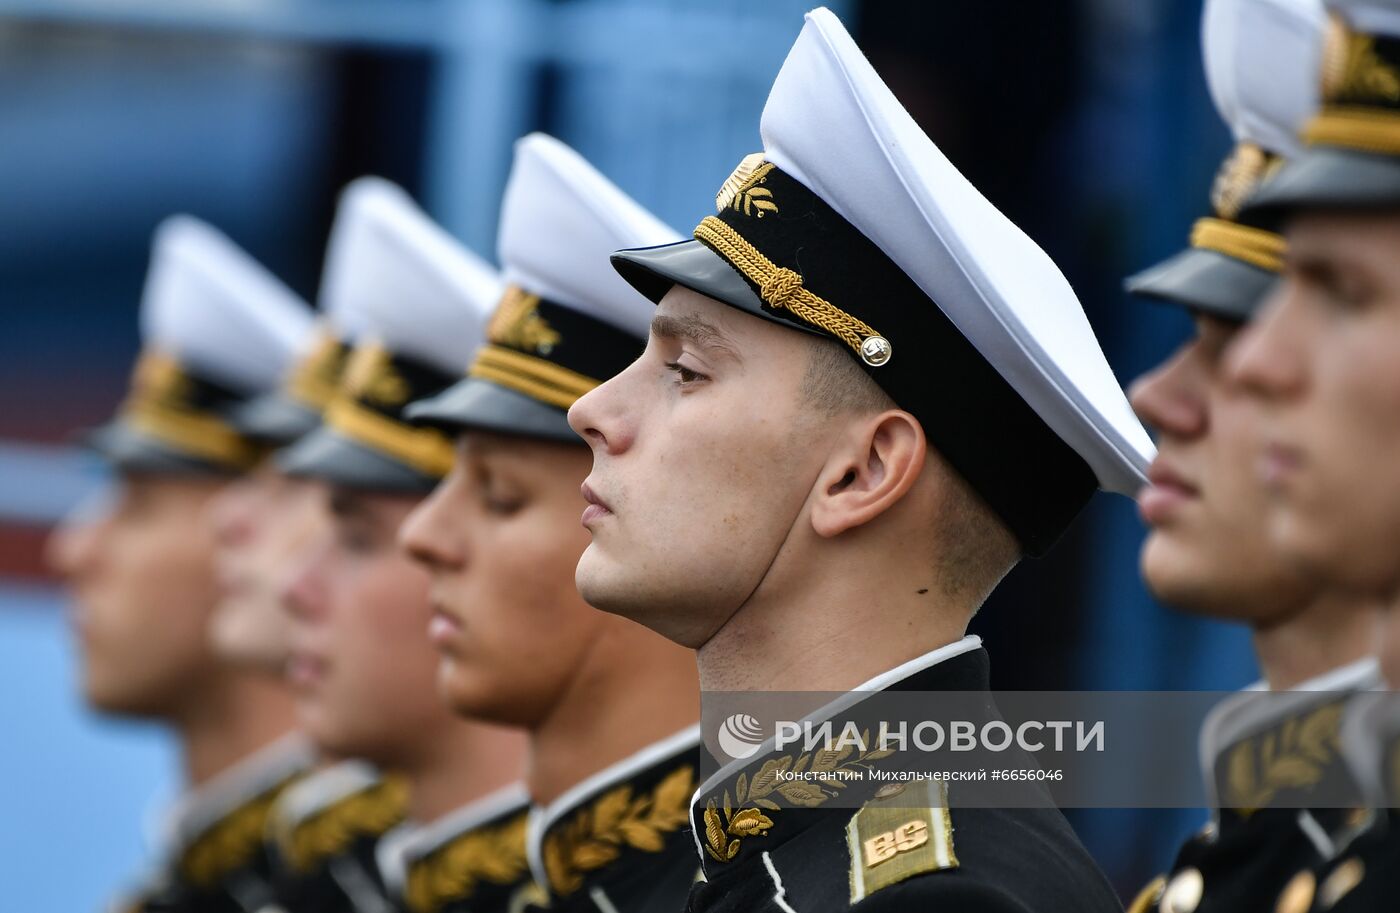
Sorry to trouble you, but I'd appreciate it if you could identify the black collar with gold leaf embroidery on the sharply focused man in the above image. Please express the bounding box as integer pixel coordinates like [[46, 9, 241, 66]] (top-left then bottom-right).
[[690, 634, 990, 877]]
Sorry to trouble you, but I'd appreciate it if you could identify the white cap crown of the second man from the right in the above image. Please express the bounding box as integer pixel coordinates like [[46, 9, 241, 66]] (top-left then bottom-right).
[[1201, 0, 1326, 157]]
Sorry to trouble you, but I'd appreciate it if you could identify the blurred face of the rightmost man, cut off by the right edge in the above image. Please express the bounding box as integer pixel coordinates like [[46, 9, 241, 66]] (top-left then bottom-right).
[[1226, 210, 1400, 595]]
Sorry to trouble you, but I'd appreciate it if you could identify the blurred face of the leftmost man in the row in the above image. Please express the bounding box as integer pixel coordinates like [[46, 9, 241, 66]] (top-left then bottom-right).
[[48, 473, 224, 718]]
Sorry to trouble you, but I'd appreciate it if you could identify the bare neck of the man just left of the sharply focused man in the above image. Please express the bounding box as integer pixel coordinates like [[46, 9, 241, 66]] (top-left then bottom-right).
[[525, 616, 700, 805]]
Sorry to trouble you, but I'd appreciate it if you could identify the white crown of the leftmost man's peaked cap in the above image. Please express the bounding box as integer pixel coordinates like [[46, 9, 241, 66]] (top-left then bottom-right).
[[141, 216, 312, 395]]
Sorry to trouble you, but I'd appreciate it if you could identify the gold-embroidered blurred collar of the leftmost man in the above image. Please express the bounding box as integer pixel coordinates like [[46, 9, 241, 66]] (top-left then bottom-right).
[[162, 734, 314, 885]]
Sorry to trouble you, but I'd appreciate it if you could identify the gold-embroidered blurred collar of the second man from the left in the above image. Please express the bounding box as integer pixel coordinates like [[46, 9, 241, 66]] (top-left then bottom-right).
[[267, 760, 409, 872]]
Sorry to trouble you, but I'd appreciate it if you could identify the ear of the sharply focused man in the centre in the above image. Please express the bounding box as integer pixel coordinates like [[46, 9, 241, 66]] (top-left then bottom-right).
[[812, 409, 928, 538]]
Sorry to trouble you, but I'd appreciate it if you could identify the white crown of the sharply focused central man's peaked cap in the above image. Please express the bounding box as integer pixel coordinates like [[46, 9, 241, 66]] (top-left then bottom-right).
[[760, 7, 1155, 494]]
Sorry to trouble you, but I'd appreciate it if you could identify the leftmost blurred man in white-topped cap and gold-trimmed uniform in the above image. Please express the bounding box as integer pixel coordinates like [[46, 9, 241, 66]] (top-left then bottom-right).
[[49, 216, 311, 913]]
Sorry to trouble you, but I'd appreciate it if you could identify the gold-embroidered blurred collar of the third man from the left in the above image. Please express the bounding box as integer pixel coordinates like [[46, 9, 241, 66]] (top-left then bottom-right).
[[377, 783, 529, 913]]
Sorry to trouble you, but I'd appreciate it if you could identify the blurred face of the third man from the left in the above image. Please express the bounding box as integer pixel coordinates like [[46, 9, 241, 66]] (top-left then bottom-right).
[[286, 483, 451, 766]]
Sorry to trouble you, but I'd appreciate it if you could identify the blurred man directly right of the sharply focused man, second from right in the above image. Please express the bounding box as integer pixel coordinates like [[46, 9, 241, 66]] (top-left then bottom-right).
[[1127, 0, 1379, 913]]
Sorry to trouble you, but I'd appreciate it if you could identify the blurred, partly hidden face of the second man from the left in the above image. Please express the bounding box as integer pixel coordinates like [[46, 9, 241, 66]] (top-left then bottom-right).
[[209, 461, 326, 674]]
